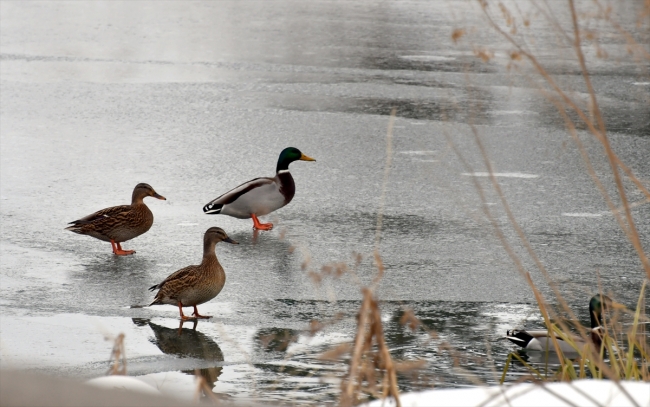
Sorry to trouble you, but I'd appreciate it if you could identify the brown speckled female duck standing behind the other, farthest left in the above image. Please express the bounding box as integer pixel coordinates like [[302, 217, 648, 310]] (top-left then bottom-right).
[[65, 184, 166, 256]]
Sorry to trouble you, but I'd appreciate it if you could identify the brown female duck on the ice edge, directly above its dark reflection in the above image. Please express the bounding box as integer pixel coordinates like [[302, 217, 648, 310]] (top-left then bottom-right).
[[149, 227, 239, 320]]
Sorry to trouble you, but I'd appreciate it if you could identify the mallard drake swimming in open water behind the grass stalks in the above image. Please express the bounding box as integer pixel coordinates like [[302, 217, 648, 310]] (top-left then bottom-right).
[[506, 294, 612, 352]]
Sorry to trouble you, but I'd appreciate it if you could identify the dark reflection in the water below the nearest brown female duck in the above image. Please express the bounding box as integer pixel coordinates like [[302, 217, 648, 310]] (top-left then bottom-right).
[[133, 318, 223, 396]]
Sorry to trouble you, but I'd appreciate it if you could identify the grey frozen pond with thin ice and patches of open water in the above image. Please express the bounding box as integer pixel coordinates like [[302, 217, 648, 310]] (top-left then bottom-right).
[[0, 1, 650, 403]]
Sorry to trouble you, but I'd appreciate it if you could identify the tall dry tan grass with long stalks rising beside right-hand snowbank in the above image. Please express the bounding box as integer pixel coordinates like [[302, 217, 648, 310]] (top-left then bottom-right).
[[464, 0, 650, 381]]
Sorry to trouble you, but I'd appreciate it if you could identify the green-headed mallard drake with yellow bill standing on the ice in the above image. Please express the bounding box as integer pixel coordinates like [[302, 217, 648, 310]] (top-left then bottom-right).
[[203, 147, 316, 230]]
